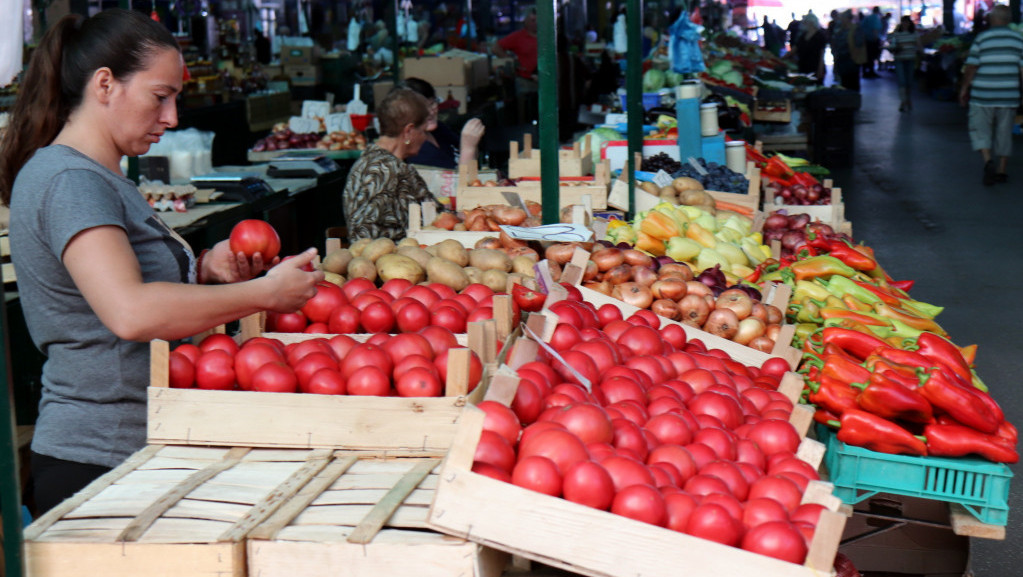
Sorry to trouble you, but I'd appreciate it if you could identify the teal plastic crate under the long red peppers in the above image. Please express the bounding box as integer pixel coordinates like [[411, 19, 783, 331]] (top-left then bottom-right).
[[817, 426, 1013, 525]]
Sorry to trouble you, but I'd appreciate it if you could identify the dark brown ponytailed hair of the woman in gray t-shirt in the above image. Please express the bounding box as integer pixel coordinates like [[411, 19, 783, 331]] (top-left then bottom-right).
[[0, 9, 180, 207]]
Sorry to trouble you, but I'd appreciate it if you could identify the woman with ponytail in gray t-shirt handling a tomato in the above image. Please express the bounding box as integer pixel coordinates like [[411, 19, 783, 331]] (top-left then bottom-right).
[[0, 9, 322, 514]]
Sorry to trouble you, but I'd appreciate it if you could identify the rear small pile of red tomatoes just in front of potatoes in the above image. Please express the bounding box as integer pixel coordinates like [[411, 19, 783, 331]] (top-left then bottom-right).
[[266, 278, 519, 335]]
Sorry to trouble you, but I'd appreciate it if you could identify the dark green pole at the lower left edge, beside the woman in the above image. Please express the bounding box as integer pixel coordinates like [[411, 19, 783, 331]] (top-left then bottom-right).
[[0, 283, 25, 577]]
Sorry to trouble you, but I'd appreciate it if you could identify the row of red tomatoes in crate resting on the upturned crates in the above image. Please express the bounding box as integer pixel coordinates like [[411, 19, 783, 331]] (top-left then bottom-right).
[[170, 325, 483, 397]]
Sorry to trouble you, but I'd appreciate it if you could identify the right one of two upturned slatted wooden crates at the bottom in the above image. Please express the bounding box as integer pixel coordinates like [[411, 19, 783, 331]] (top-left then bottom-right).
[[248, 454, 507, 577]]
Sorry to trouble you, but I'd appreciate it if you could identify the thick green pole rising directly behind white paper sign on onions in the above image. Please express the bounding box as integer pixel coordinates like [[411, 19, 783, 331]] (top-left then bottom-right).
[[536, 0, 561, 224]]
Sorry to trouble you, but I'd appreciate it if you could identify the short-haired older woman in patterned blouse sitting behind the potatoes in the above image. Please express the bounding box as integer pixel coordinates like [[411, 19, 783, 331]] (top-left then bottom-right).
[[342, 88, 436, 240]]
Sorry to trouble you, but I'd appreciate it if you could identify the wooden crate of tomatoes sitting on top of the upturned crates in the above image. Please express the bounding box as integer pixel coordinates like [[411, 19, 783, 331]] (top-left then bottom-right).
[[148, 323, 490, 455]]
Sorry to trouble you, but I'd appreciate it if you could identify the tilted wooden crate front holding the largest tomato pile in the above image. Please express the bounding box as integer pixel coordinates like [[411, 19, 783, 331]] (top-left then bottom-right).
[[430, 407, 845, 577]]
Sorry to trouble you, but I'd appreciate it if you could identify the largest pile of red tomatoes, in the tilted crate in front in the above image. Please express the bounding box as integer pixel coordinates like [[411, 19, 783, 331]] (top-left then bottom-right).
[[473, 301, 824, 564]]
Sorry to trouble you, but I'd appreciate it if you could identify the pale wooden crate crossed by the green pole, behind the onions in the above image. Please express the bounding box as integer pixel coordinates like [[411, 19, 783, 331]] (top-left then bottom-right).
[[455, 165, 610, 210]]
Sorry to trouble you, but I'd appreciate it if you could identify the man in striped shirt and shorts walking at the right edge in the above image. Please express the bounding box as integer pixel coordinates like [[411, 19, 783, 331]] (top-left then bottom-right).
[[960, 4, 1023, 186]]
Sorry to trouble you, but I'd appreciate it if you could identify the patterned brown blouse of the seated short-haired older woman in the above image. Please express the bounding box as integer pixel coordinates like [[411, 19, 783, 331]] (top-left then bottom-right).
[[342, 144, 437, 241]]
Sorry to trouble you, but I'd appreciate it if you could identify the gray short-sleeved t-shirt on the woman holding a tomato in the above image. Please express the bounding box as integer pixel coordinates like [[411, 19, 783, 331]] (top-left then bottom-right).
[[10, 145, 195, 467]]
